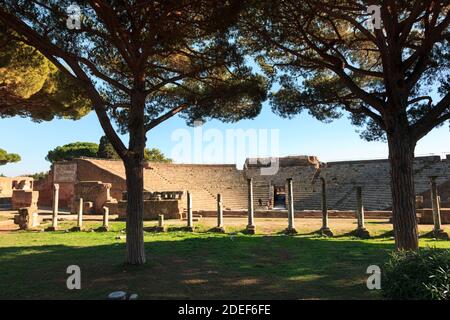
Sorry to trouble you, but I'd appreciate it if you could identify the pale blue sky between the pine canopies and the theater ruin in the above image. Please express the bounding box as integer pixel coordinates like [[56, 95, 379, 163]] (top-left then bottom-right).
[[0, 104, 450, 176]]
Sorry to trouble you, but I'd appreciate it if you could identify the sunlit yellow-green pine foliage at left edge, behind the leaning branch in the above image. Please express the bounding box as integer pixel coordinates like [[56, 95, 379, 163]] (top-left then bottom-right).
[[0, 24, 91, 121]]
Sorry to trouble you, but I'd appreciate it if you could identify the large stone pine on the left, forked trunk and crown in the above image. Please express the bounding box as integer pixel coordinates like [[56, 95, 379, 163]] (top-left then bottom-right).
[[0, 0, 266, 264]]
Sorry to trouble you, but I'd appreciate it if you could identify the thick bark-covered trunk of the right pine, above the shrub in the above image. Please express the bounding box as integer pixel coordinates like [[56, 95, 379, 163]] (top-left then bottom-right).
[[387, 120, 419, 250]]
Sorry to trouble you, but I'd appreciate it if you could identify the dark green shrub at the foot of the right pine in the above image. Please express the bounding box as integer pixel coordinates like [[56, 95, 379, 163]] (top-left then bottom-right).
[[382, 248, 450, 300]]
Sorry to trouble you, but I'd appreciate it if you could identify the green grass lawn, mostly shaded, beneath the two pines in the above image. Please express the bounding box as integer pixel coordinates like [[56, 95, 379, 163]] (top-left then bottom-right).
[[0, 222, 450, 299]]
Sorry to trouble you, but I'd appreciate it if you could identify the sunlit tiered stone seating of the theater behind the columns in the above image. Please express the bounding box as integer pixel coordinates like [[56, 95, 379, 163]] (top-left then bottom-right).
[[81, 156, 450, 211]]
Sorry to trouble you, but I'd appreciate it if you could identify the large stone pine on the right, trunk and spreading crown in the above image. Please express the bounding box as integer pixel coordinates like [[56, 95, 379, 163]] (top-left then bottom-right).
[[241, 0, 450, 249]]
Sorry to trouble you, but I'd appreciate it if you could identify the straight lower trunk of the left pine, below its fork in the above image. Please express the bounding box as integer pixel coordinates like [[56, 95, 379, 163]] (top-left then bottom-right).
[[125, 160, 145, 265]]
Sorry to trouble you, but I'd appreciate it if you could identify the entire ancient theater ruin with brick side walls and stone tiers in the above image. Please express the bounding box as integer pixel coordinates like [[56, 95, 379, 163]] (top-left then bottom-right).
[[27, 155, 450, 223]]
